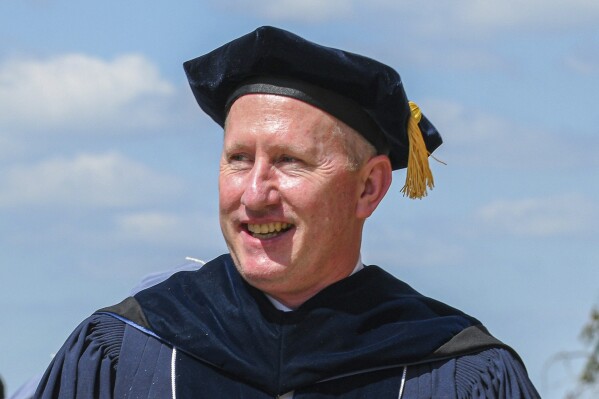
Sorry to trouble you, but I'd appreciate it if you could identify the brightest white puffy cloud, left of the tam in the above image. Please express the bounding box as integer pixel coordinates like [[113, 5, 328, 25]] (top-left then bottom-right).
[[0, 54, 174, 131]]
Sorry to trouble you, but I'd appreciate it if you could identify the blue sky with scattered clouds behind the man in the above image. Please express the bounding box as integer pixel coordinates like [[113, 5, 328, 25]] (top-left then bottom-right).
[[0, 0, 599, 398]]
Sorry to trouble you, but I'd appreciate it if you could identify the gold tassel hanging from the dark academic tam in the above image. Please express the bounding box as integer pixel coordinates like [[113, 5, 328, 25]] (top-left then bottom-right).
[[401, 101, 435, 199]]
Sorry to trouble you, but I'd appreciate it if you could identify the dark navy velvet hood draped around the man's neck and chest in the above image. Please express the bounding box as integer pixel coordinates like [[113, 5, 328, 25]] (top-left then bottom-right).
[[95, 255, 506, 394]]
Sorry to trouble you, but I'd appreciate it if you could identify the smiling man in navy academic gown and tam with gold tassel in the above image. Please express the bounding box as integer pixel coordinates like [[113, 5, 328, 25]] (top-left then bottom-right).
[[36, 27, 538, 399]]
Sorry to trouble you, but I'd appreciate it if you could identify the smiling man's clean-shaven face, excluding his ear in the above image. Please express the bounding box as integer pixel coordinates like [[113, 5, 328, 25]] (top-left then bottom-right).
[[219, 94, 363, 305]]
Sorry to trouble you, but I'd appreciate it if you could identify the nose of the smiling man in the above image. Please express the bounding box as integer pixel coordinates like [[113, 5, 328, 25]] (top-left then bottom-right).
[[241, 161, 280, 210]]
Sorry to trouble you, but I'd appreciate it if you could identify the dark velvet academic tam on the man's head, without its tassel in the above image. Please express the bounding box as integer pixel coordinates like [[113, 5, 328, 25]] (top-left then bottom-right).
[[183, 26, 443, 169]]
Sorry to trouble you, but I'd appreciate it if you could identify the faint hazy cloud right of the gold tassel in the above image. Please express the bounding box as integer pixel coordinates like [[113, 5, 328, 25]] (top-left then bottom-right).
[[420, 100, 597, 170]]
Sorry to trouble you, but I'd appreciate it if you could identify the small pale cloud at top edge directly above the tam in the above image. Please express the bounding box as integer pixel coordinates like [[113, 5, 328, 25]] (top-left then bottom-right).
[[221, 0, 354, 22]]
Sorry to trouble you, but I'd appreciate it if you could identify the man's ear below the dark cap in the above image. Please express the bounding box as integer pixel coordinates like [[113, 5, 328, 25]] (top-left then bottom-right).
[[356, 155, 392, 219]]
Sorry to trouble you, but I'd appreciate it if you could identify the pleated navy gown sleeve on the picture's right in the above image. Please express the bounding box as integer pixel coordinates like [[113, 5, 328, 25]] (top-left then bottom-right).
[[455, 349, 540, 399]]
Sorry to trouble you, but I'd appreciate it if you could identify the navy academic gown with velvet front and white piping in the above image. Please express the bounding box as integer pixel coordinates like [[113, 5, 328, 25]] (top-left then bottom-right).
[[36, 255, 539, 399]]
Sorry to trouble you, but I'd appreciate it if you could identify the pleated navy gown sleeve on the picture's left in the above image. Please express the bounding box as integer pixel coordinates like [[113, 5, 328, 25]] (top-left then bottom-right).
[[35, 314, 125, 399]]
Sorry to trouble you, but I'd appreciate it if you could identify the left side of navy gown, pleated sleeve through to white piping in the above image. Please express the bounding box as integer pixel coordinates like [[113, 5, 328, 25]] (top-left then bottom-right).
[[35, 314, 172, 399]]
